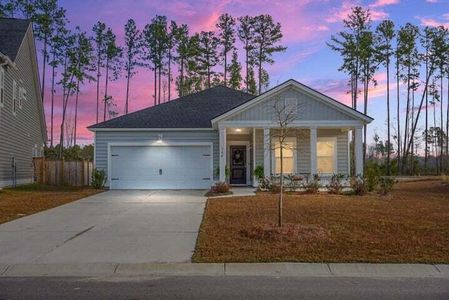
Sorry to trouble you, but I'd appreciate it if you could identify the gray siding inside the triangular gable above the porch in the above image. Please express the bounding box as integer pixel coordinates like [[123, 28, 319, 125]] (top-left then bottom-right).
[[227, 88, 354, 121]]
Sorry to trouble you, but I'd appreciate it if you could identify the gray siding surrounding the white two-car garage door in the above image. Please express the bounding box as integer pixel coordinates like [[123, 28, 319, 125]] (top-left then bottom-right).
[[95, 130, 219, 184]]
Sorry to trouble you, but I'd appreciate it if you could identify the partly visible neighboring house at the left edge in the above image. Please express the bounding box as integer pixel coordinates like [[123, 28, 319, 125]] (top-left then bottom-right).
[[0, 18, 46, 187]]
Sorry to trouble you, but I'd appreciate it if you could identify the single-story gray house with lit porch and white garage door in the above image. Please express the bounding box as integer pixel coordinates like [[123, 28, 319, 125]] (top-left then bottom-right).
[[89, 80, 373, 189]]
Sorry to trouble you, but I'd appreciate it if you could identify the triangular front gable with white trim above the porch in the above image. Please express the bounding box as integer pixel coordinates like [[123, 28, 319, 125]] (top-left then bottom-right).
[[212, 80, 373, 124]]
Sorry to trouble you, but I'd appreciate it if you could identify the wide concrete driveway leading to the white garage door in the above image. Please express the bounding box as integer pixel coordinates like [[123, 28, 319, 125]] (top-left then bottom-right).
[[0, 190, 206, 264]]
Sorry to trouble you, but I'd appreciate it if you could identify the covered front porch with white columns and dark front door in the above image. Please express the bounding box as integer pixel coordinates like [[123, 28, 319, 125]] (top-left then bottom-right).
[[219, 124, 363, 187]]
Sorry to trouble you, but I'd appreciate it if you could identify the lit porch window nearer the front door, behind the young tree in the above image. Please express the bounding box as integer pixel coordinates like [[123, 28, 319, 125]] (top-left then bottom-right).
[[273, 137, 296, 174]]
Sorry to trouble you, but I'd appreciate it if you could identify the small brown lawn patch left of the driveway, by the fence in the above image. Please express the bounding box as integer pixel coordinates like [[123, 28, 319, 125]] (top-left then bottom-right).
[[0, 184, 101, 224]]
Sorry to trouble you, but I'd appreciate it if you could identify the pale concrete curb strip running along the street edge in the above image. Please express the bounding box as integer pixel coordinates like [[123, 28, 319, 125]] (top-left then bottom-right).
[[0, 263, 449, 278]]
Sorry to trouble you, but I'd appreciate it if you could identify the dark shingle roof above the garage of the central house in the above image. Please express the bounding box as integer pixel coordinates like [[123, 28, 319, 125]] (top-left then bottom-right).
[[89, 85, 255, 129]]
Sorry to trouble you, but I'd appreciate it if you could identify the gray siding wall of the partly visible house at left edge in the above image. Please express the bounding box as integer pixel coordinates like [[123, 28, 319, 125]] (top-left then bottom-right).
[[0, 30, 45, 186]]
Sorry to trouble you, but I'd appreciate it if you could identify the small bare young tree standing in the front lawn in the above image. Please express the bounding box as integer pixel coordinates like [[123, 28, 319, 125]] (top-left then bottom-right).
[[270, 99, 299, 227]]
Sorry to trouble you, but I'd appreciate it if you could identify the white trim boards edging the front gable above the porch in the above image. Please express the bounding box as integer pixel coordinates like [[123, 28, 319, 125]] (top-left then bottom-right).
[[211, 79, 374, 125]]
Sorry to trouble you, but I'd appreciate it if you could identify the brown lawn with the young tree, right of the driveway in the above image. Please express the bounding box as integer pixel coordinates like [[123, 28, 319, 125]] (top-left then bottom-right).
[[193, 181, 449, 263]]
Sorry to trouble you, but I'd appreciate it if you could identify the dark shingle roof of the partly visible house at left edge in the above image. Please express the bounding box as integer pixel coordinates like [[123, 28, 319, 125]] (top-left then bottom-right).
[[0, 18, 30, 61]]
